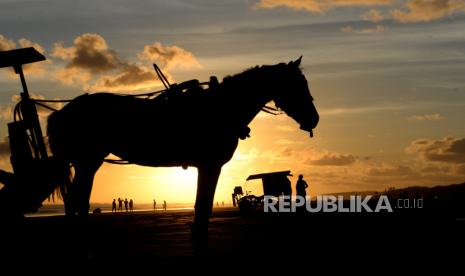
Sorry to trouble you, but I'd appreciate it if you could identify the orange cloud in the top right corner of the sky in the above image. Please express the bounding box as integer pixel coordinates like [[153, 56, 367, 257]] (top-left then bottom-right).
[[391, 0, 465, 23]]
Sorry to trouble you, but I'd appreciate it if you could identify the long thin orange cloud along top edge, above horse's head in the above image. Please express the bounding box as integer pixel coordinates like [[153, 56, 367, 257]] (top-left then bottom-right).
[[253, 0, 393, 13]]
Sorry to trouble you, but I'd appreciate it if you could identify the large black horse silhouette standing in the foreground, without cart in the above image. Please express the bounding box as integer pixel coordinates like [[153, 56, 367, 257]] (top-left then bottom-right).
[[47, 58, 319, 246]]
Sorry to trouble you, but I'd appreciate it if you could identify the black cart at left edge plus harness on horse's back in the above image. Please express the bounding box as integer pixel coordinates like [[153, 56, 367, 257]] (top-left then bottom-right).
[[0, 47, 212, 218]]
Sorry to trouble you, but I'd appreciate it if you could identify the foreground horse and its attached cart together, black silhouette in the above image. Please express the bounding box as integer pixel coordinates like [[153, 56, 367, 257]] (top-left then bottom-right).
[[0, 48, 319, 246]]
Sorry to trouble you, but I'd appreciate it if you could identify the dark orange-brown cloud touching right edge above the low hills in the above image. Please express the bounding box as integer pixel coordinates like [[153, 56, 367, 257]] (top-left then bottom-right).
[[405, 137, 465, 164]]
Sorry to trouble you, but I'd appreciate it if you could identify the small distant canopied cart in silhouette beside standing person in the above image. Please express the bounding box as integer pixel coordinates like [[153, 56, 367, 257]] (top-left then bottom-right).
[[232, 171, 292, 213]]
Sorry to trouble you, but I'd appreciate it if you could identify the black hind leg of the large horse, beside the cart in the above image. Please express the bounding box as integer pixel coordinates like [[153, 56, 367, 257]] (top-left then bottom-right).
[[71, 159, 103, 218]]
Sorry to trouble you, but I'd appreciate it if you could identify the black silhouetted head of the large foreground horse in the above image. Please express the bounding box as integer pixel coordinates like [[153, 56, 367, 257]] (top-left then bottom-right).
[[272, 57, 319, 137]]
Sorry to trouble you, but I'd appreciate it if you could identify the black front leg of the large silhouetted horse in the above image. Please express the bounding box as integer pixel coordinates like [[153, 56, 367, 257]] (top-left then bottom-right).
[[191, 164, 222, 248]]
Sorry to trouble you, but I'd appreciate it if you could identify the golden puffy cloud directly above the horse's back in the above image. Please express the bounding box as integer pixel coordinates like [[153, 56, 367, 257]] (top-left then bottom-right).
[[139, 42, 201, 70]]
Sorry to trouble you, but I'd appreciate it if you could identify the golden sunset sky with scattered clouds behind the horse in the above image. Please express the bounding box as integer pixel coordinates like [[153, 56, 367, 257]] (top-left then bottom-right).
[[0, 0, 465, 203]]
